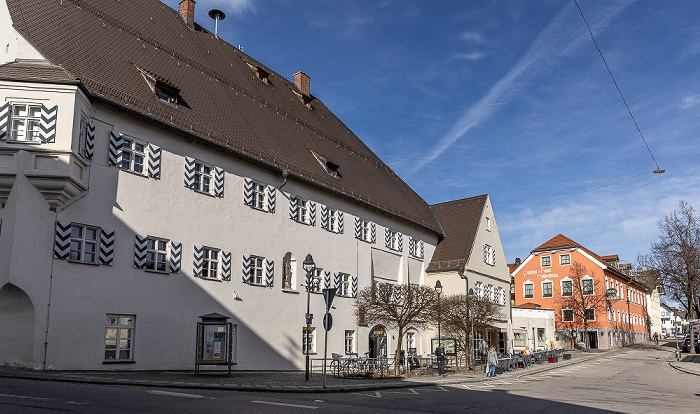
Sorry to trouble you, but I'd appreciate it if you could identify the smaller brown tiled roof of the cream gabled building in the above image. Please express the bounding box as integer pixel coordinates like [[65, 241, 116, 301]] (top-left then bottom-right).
[[426, 194, 488, 272]]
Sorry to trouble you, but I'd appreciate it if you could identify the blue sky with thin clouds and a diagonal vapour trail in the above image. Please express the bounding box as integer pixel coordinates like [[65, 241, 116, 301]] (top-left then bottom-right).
[[165, 0, 700, 263]]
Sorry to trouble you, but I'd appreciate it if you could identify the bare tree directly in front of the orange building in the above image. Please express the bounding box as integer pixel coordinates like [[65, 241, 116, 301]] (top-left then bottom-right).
[[555, 262, 610, 350]]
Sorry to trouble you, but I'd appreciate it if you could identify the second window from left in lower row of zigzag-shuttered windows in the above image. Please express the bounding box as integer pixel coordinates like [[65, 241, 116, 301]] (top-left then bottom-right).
[[134, 234, 182, 273]]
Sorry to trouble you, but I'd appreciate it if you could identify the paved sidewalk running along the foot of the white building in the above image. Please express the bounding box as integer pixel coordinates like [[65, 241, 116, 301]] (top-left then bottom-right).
[[0, 349, 620, 393]]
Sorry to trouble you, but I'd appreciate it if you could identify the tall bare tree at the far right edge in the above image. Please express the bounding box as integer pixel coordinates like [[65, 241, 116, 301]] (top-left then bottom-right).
[[637, 200, 700, 353]]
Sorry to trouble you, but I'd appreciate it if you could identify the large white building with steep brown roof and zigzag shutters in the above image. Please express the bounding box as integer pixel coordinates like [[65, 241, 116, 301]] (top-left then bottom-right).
[[0, 0, 460, 370]]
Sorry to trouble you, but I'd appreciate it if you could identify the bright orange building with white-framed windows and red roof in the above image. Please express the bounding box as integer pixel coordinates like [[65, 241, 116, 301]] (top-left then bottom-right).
[[512, 234, 649, 349]]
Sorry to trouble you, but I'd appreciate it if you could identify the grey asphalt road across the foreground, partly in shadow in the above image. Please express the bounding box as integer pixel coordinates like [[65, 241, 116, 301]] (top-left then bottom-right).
[[0, 347, 700, 414]]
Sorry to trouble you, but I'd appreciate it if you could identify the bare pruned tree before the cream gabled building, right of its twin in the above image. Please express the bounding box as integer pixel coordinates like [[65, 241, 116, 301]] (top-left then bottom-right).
[[433, 294, 503, 368]]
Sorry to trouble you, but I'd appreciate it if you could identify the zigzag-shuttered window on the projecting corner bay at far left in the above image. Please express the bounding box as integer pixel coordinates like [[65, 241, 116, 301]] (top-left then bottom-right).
[[0, 102, 58, 143]]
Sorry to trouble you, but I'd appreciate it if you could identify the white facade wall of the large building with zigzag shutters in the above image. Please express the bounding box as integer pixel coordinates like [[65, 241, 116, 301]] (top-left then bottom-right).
[[0, 2, 446, 370]]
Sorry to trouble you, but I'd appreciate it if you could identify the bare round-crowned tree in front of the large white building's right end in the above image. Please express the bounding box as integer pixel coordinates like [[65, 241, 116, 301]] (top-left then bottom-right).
[[355, 283, 436, 376]]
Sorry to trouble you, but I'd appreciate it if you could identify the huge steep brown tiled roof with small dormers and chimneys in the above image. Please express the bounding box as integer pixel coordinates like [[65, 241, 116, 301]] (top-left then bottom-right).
[[7, 0, 441, 234]]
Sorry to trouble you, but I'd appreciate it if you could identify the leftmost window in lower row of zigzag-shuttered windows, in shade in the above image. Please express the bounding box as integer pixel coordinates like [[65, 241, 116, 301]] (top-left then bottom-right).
[[54, 221, 114, 265]]
